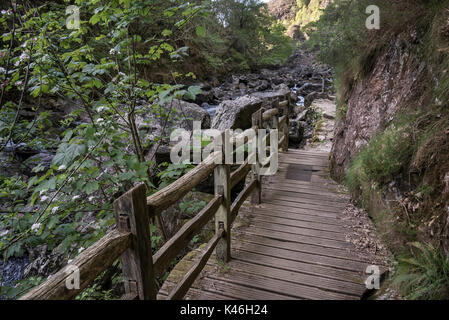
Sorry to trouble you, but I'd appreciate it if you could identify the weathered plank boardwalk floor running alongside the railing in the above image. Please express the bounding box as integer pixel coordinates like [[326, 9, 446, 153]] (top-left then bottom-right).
[[158, 150, 369, 300]]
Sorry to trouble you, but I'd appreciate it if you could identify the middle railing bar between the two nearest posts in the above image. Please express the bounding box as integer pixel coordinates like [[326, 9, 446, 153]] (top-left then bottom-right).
[[153, 195, 223, 277]]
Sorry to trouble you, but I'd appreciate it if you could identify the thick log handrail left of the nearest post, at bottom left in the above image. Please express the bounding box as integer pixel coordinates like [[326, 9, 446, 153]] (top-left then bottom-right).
[[19, 230, 132, 300]]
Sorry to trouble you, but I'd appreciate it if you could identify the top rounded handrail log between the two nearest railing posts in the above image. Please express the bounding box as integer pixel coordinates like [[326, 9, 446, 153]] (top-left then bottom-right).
[[147, 151, 222, 216]]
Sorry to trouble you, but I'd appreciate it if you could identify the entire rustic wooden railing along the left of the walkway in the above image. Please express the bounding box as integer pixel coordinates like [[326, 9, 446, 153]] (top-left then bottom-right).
[[21, 94, 290, 300]]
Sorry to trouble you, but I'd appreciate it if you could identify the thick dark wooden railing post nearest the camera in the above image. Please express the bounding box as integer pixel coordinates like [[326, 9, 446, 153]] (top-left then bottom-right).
[[114, 184, 157, 300]]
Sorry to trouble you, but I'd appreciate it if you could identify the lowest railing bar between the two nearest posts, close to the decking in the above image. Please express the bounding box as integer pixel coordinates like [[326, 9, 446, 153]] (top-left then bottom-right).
[[167, 229, 225, 300]]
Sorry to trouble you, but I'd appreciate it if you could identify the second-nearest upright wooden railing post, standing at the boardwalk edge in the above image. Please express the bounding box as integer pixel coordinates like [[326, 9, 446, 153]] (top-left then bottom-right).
[[214, 132, 232, 263]]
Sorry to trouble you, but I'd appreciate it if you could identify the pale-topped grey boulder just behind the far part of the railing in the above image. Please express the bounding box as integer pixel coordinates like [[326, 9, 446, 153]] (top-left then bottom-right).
[[212, 95, 262, 130]]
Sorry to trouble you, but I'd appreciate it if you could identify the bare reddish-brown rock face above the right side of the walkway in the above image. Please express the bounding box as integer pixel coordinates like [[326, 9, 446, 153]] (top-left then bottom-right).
[[331, 30, 433, 179]]
